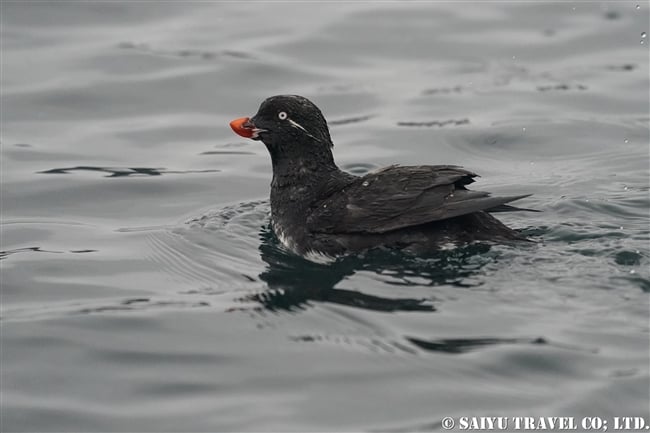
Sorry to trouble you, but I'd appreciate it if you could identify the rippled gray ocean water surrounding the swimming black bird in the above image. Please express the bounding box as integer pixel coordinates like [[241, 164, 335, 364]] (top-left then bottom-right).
[[0, 1, 650, 432]]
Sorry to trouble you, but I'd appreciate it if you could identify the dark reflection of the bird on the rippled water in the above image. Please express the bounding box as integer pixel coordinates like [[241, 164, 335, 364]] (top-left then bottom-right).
[[252, 227, 494, 312]]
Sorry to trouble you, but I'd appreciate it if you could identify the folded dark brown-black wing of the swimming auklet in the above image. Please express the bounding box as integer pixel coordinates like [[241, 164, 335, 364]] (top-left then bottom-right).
[[307, 165, 527, 233]]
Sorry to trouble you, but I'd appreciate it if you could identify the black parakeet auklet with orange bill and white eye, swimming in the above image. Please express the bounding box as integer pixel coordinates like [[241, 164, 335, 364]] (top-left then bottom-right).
[[230, 95, 528, 261]]
